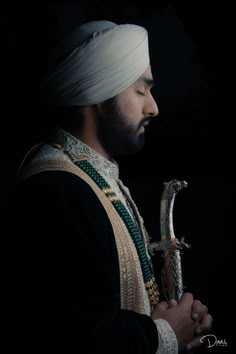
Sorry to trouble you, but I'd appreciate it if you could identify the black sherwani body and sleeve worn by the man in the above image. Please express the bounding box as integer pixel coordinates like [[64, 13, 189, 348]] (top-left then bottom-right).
[[3, 171, 158, 354]]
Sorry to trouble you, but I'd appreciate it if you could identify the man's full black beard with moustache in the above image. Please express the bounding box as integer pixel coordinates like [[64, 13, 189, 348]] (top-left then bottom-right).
[[97, 98, 151, 157]]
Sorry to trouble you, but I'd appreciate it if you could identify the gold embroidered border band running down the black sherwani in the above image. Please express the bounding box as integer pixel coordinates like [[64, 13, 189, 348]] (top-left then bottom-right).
[[18, 154, 144, 313]]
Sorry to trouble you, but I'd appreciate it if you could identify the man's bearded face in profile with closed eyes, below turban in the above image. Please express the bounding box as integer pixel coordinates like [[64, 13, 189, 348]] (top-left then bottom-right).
[[97, 67, 158, 156]]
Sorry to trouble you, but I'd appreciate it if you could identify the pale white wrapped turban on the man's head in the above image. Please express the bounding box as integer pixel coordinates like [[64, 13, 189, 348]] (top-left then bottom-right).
[[43, 21, 149, 106]]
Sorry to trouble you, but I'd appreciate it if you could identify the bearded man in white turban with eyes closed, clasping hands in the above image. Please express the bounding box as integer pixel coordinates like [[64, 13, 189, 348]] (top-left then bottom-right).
[[6, 21, 212, 354]]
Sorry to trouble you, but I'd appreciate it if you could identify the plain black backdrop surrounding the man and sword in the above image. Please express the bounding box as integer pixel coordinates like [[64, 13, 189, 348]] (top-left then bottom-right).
[[0, 0, 236, 354]]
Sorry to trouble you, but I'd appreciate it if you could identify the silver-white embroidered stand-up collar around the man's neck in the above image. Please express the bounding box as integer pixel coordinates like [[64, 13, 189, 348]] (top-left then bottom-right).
[[53, 129, 119, 181]]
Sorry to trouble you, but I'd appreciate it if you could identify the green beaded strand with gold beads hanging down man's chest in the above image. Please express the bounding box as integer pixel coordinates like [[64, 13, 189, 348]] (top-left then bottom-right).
[[74, 160, 160, 305]]
